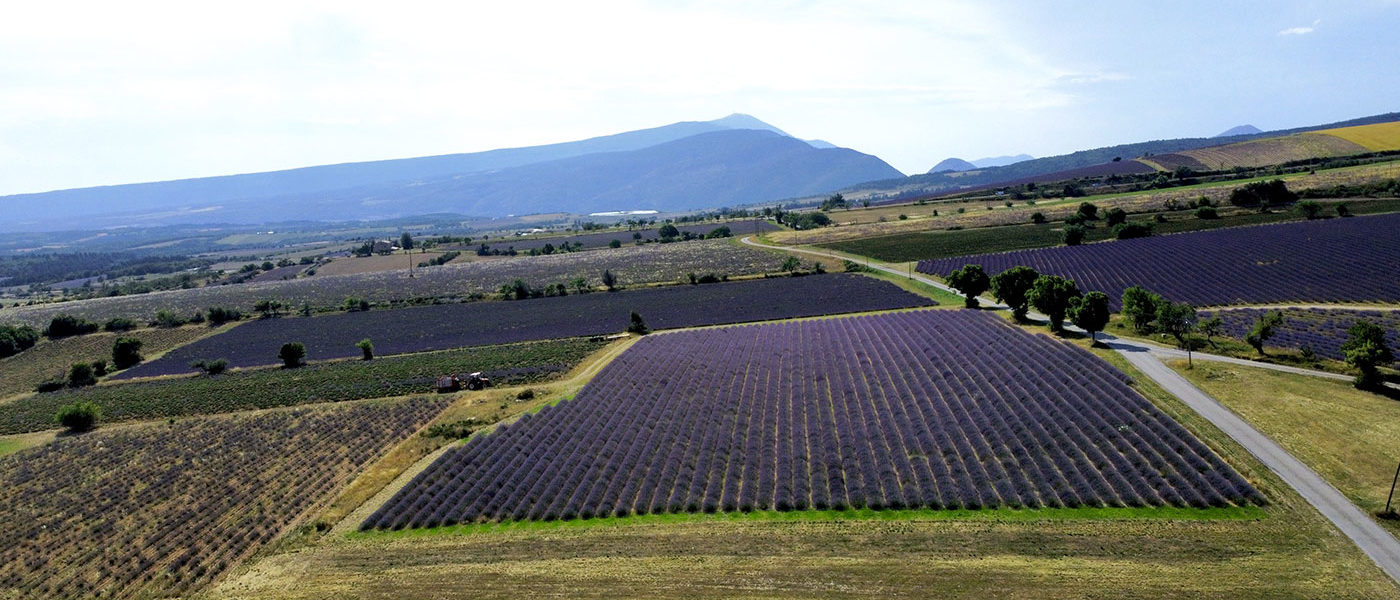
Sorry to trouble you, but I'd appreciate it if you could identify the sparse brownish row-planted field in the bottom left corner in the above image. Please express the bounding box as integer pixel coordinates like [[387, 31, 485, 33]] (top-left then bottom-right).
[[0, 397, 448, 599]]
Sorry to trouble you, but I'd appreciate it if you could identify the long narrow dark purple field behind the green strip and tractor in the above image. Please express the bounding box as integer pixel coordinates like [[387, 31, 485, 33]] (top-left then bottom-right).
[[116, 274, 935, 379]]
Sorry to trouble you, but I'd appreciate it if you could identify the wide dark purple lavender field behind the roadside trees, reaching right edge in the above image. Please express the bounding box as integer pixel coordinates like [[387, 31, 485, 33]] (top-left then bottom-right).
[[918, 214, 1400, 310]]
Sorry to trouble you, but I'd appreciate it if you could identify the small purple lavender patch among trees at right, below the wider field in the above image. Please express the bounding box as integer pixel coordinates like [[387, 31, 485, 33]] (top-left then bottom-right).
[[1200, 308, 1400, 361]]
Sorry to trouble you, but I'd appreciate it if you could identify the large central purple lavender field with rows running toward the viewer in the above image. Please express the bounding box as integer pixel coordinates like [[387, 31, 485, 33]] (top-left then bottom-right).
[[361, 310, 1263, 529]]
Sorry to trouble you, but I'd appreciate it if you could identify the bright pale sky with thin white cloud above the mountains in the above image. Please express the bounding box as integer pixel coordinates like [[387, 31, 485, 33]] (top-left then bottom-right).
[[0, 0, 1400, 194]]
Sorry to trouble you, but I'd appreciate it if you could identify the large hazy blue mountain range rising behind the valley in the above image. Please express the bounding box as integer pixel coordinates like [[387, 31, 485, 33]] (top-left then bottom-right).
[[0, 113, 903, 231]]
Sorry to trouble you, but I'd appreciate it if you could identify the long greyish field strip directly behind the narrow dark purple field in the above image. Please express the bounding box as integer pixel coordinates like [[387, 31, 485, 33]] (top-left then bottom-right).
[[0, 239, 783, 327]]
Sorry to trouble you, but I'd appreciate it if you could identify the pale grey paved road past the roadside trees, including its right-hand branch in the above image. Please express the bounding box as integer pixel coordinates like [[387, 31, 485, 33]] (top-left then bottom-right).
[[743, 238, 1400, 583]]
